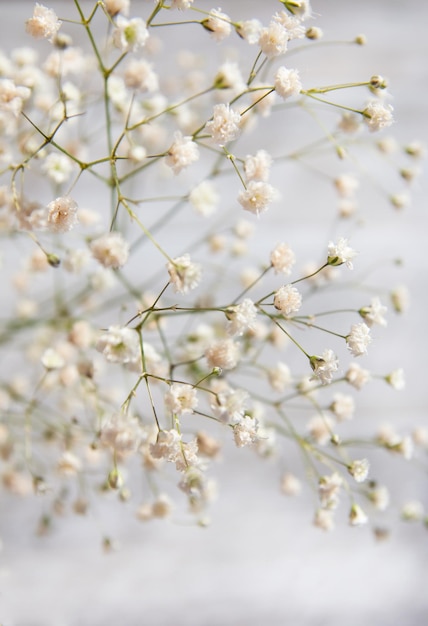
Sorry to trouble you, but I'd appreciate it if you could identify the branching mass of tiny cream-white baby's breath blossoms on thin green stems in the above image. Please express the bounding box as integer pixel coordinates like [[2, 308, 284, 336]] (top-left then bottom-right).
[[0, 0, 422, 548]]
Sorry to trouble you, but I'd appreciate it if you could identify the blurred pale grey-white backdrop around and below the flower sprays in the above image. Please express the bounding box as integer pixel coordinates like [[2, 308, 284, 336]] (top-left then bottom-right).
[[0, 0, 428, 626]]
